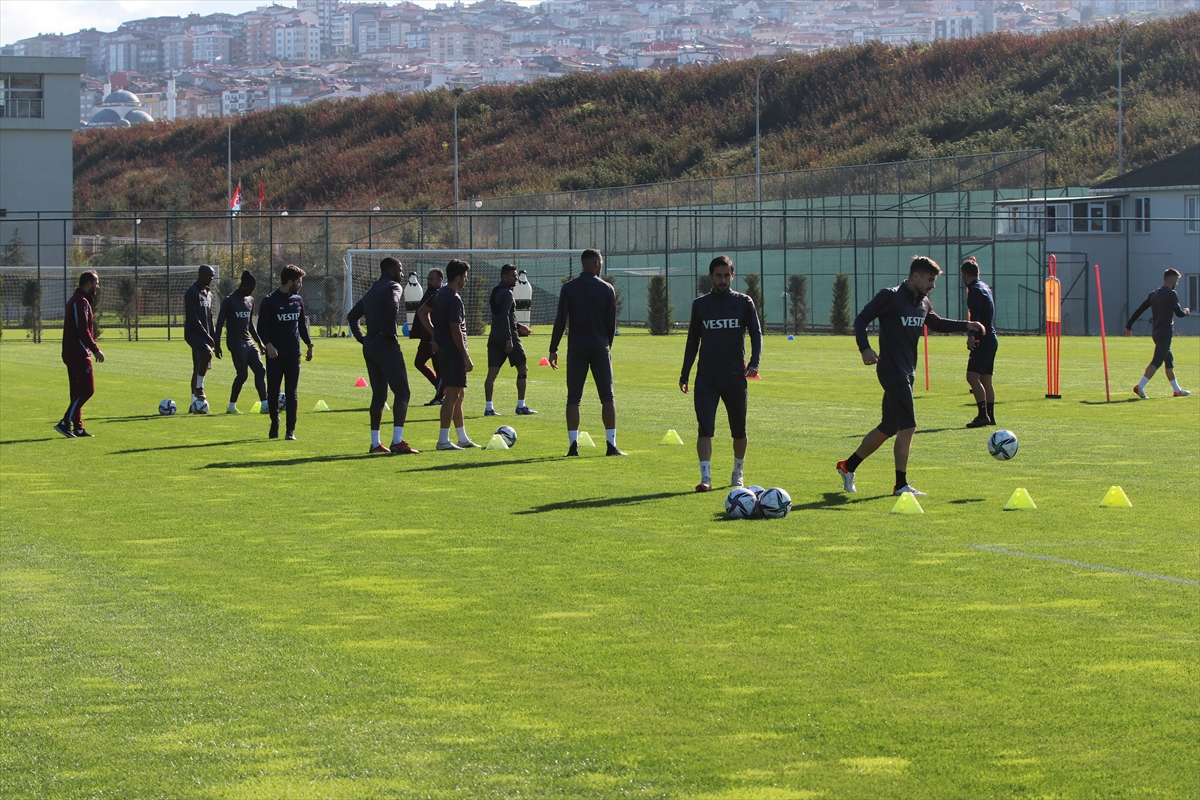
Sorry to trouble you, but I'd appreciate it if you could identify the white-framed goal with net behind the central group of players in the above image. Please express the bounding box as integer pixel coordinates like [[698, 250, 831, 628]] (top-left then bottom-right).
[[346, 249, 580, 336]]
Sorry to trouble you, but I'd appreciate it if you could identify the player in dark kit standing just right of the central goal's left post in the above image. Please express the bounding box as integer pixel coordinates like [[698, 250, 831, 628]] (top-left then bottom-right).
[[346, 255, 419, 456]]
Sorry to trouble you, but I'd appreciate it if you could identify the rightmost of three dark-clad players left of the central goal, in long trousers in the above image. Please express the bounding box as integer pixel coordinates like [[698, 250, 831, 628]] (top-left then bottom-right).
[[258, 264, 312, 439]]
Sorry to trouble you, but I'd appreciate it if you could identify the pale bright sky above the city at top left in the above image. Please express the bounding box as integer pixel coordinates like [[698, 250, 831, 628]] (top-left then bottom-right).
[[0, 0, 538, 44]]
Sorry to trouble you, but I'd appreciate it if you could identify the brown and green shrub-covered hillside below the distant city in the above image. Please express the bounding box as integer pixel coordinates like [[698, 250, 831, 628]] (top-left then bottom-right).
[[74, 14, 1200, 210]]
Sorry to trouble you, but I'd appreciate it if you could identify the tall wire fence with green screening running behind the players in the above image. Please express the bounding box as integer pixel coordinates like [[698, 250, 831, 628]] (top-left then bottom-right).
[[0, 151, 1045, 339]]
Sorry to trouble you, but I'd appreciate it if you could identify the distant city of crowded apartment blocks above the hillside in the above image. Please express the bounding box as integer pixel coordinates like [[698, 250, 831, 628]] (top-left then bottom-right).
[[0, 0, 1200, 128]]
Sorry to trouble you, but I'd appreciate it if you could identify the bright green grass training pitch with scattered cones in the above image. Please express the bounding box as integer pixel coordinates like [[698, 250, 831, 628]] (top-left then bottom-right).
[[0, 332, 1200, 799]]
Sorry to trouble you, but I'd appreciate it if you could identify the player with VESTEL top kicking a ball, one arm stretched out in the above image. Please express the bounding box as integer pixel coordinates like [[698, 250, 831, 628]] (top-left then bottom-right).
[[838, 255, 988, 495]]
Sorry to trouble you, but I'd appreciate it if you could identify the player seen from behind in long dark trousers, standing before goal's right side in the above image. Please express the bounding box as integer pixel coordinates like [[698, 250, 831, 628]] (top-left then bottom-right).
[[550, 247, 625, 456]]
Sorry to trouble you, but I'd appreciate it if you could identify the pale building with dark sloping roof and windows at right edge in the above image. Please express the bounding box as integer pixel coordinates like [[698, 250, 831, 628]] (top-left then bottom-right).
[[996, 145, 1200, 336]]
